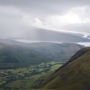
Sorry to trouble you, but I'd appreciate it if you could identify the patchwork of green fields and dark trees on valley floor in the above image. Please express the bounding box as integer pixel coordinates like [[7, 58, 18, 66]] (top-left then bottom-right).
[[0, 61, 62, 90]]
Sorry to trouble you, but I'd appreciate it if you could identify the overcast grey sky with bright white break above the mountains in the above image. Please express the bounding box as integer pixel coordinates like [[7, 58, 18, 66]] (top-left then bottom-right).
[[0, 0, 90, 38]]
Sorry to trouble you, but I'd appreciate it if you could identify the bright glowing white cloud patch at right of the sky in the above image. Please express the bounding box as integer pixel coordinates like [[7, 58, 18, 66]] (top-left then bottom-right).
[[34, 6, 90, 33]]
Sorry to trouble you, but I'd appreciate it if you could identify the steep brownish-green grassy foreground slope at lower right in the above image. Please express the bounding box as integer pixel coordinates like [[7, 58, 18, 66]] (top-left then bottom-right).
[[42, 48, 90, 90]]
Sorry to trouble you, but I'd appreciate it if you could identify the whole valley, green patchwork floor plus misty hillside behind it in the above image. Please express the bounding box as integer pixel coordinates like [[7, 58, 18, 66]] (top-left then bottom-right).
[[0, 40, 83, 90]]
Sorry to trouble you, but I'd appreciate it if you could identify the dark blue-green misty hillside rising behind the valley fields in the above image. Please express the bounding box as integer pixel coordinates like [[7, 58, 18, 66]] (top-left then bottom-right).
[[0, 40, 82, 69]]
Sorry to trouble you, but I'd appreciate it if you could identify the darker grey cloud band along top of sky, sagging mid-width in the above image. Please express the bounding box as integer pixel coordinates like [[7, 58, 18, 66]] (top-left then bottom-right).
[[0, 0, 90, 14]]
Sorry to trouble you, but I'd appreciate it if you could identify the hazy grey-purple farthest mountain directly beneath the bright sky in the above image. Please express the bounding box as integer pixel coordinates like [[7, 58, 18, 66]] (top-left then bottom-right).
[[15, 29, 90, 43]]
